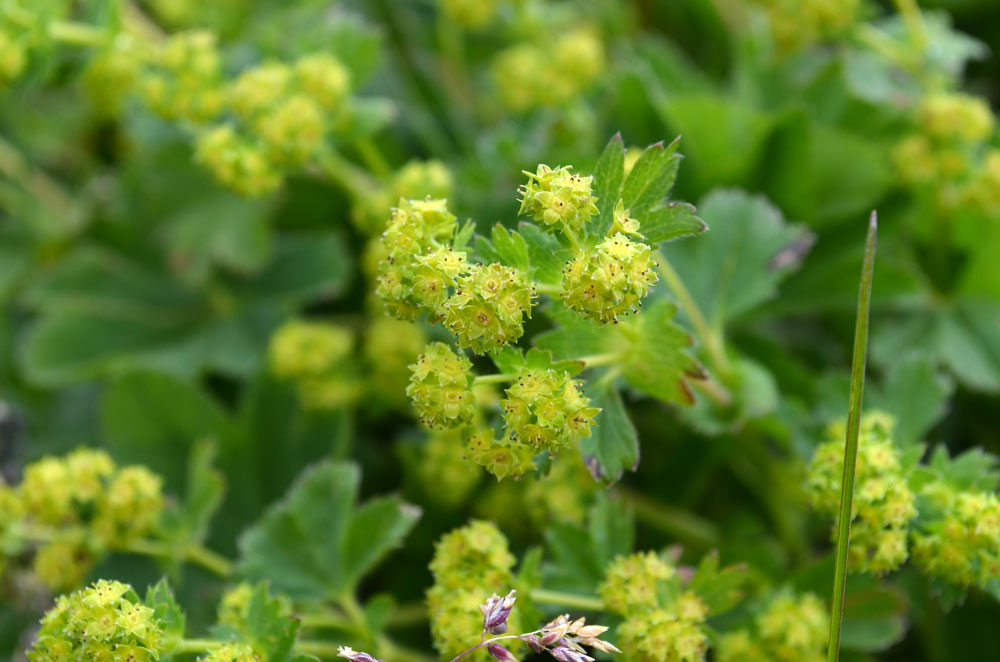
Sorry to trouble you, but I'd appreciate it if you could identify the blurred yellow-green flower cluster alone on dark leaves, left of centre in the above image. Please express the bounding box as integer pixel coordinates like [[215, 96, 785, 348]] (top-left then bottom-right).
[[268, 320, 361, 410]]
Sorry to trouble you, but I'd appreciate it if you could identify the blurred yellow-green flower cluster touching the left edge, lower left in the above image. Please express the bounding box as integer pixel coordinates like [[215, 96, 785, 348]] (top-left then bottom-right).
[[0, 449, 163, 590]]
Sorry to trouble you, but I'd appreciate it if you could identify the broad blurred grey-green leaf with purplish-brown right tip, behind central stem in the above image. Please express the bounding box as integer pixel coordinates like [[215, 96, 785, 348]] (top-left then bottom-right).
[[656, 190, 812, 322]]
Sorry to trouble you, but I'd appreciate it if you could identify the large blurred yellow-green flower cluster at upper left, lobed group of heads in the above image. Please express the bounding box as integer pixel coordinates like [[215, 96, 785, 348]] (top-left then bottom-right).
[[196, 53, 351, 196]]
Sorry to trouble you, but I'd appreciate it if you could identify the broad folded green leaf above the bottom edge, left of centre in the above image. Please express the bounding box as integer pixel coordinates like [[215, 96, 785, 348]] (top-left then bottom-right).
[[238, 462, 420, 601]]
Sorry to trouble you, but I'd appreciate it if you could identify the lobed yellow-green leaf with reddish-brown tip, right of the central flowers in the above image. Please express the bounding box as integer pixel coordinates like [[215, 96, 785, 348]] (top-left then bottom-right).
[[620, 300, 703, 404]]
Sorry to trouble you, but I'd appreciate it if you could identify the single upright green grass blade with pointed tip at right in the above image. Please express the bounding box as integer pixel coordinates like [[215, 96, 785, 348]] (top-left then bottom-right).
[[827, 212, 878, 662]]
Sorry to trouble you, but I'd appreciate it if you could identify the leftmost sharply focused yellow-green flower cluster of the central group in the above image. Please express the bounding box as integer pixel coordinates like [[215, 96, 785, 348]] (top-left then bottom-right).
[[375, 198, 467, 319]]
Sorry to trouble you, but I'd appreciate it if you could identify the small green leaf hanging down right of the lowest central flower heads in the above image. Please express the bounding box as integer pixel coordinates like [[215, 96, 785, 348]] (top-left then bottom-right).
[[580, 380, 639, 483]]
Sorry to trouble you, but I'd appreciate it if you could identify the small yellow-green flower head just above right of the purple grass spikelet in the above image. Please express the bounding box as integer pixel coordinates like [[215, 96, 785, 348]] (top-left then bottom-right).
[[598, 552, 677, 616]]
